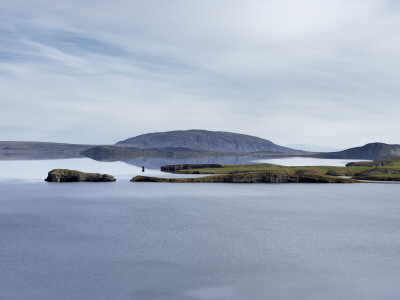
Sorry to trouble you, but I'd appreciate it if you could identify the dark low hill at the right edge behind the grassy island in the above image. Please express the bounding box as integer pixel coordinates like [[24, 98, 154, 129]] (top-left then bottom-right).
[[317, 143, 400, 160]]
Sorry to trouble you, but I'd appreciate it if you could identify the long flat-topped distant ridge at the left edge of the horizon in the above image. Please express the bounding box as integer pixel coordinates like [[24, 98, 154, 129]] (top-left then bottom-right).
[[0, 141, 94, 160]]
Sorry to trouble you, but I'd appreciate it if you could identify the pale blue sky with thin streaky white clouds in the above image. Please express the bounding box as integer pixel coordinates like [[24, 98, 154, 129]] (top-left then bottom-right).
[[0, 0, 400, 148]]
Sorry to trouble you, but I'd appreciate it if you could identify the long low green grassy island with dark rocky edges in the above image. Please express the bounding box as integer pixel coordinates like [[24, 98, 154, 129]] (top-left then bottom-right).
[[131, 158, 400, 183]]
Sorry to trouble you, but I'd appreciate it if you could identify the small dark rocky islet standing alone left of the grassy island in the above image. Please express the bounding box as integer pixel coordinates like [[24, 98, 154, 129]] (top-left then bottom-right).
[[45, 169, 116, 182]]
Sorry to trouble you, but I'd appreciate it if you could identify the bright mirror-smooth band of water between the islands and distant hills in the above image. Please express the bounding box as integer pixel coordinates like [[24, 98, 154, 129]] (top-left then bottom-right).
[[0, 156, 368, 181]]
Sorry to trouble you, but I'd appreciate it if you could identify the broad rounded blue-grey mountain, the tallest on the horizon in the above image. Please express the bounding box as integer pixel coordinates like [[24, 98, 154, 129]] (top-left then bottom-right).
[[116, 130, 301, 153]]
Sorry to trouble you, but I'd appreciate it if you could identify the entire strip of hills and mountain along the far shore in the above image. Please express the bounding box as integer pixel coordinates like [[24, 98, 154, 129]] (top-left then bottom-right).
[[0, 129, 400, 161]]
